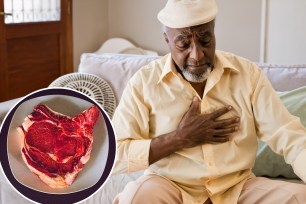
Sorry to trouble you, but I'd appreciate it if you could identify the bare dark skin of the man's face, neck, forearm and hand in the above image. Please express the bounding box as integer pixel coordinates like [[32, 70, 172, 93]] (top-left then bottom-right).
[[149, 21, 240, 164]]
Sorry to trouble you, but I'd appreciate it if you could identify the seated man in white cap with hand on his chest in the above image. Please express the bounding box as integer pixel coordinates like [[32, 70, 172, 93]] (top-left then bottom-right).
[[113, 0, 306, 204]]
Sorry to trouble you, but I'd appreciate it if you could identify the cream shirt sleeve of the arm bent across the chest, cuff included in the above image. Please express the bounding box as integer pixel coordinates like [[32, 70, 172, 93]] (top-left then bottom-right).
[[113, 77, 151, 174]]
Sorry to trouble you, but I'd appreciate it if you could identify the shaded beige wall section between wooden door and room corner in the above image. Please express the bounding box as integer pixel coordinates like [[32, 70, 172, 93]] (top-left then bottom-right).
[[73, 0, 108, 71]]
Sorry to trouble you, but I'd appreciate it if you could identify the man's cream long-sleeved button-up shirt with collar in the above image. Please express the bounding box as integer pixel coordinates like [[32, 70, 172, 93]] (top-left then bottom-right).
[[113, 51, 306, 204]]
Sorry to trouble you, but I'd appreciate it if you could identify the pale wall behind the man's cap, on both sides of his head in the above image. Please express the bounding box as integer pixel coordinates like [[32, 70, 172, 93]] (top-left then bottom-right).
[[108, 0, 261, 61]]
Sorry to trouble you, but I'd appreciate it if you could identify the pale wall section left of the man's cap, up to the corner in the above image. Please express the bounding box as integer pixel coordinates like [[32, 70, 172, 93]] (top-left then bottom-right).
[[109, 0, 167, 54]]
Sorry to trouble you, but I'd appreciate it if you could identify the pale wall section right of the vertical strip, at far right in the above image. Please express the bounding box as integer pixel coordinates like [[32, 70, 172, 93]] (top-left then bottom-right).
[[265, 0, 306, 64]]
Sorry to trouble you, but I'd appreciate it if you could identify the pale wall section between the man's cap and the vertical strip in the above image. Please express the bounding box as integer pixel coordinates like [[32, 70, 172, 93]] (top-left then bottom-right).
[[216, 0, 261, 61]]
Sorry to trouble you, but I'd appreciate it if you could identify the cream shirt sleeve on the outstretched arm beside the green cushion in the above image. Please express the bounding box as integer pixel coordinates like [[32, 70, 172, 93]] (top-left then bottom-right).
[[251, 67, 306, 182]]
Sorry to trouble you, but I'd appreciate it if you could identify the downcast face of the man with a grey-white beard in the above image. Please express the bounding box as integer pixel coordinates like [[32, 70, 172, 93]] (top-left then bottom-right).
[[164, 21, 216, 83]]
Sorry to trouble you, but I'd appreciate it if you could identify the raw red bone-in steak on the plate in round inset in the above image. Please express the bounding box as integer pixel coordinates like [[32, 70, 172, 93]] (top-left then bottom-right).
[[18, 104, 100, 188]]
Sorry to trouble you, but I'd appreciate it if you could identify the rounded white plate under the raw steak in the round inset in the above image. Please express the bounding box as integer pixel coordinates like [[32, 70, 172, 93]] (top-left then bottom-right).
[[7, 95, 109, 194]]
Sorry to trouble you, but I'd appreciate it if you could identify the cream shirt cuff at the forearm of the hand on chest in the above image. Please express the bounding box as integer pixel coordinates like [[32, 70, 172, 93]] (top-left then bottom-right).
[[128, 140, 151, 173]]
